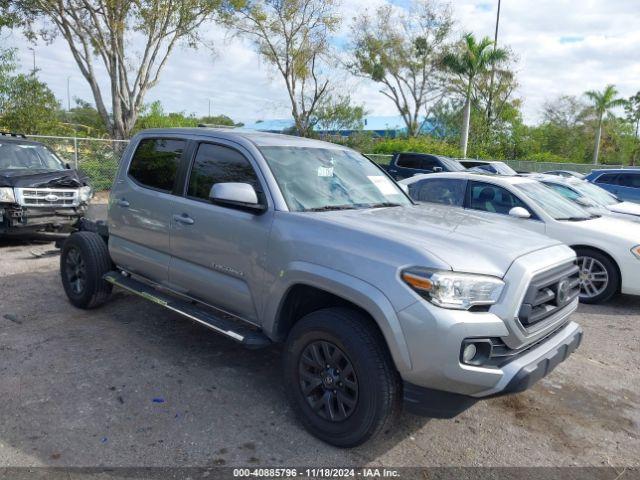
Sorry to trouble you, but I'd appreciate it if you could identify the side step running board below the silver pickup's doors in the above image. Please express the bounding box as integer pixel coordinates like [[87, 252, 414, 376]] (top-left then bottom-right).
[[103, 272, 271, 348]]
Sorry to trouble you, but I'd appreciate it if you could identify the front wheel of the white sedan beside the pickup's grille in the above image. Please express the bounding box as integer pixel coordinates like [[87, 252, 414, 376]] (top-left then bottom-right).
[[575, 248, 620, 304]]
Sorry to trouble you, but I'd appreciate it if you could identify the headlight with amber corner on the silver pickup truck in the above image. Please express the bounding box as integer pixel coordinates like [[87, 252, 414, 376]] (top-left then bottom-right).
[[402, 268, 504, 310]]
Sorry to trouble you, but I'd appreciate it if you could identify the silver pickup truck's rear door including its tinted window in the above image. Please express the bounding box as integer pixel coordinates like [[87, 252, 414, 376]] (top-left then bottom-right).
[[109, 137, 187, 283]]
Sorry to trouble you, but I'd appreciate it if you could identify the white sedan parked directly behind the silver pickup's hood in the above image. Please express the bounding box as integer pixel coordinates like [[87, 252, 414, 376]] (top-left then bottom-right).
[[402, 173, 640, 303]]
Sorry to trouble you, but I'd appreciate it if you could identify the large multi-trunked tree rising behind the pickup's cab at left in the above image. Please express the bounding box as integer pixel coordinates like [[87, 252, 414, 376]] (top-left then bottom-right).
[[0, 0, 233, 139]]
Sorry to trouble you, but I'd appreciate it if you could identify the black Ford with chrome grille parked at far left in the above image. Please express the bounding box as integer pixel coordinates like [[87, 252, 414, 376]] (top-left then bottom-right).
[[0, 132, 92, 236]]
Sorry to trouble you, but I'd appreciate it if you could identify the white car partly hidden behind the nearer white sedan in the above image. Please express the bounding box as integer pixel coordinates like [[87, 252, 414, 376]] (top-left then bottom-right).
[[530, 174, 640, 222]]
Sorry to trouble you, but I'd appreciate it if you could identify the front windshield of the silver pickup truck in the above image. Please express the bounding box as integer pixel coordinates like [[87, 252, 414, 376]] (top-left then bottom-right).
[[260, 147, 411, 212]]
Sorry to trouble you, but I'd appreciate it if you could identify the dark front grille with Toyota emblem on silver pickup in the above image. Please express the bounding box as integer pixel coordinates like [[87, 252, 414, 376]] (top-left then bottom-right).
[[518, 263, 580, 330]]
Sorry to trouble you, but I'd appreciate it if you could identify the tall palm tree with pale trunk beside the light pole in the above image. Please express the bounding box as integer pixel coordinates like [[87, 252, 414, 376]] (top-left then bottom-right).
[[442, 33, 508, 158]]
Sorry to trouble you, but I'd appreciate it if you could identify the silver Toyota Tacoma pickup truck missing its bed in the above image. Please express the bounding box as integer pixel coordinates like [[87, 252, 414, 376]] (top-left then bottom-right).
[[60, 129, 582, 447]]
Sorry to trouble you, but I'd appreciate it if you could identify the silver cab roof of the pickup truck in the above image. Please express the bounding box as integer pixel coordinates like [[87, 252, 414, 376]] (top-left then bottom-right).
[[134, 127, 349, 150]]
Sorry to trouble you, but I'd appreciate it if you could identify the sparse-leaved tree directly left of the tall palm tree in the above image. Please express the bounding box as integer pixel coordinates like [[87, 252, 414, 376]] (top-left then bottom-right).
[[348, 0, 453, 136]]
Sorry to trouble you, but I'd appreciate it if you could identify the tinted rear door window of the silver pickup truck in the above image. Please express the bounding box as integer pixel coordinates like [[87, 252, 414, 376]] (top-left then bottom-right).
[[129, 138, 187, 192]]
